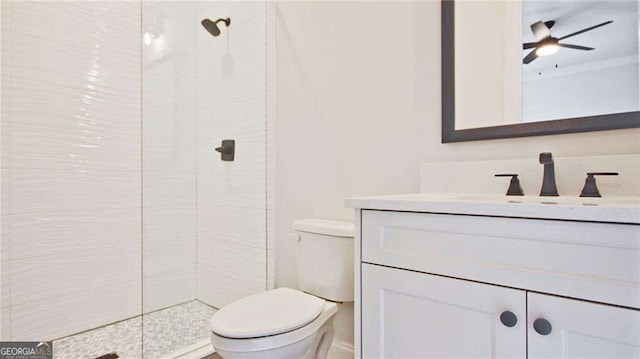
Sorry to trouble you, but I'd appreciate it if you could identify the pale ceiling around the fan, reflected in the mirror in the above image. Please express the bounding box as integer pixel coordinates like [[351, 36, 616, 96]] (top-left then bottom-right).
[[522, 0, 639, 75]]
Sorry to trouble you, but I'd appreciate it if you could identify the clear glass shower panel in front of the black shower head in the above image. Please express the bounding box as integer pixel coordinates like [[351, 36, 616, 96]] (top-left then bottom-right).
[[141, 1, 267, 358]]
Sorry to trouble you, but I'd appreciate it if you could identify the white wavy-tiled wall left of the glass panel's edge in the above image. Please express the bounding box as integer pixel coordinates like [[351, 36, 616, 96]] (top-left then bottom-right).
[[0, 1, 141, 341]]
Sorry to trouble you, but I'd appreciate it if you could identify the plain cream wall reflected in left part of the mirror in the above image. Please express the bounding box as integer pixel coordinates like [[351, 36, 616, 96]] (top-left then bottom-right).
[[454, 1, 522, 129]]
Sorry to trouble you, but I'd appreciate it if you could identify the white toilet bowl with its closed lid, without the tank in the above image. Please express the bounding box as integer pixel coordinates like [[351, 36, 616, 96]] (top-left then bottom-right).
[[210, 288, 338, 359]]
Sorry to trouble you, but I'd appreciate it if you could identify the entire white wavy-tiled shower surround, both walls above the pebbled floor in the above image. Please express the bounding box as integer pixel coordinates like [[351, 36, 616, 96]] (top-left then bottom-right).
[[0, 1, 275, 340]]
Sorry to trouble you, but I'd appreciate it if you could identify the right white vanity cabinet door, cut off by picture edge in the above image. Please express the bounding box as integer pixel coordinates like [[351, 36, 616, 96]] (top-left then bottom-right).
[[527, 293, 640, 359]]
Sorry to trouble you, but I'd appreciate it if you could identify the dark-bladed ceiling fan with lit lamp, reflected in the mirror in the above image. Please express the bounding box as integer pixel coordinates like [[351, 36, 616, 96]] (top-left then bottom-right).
[[522, 20, 613, 65]]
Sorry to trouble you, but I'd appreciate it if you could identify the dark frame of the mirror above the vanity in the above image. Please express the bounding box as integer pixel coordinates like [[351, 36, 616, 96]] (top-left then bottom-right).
[[441, 0, 640, 143]]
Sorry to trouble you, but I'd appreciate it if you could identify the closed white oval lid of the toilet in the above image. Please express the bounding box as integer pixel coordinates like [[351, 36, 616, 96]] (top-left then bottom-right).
[[211, 288, 325, 338]]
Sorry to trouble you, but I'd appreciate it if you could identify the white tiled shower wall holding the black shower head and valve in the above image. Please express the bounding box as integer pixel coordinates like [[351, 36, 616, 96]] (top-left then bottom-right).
[[195, 1, 274, 308]]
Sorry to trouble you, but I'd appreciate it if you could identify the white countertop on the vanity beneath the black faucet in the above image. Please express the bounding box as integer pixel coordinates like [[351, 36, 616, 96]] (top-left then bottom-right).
[[345, 193, 640, 224]]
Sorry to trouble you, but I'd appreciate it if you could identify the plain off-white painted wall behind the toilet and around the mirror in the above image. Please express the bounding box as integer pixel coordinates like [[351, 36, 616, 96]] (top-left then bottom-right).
[[276, 1, 640, 352]]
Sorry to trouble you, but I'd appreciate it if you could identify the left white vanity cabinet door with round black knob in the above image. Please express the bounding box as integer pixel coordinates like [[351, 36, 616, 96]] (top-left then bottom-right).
[[361, 264, 526, 358]]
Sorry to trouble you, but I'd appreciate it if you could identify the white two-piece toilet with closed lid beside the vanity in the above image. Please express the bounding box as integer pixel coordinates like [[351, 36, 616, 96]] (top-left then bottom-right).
[[210, 219, 354, 359]]
